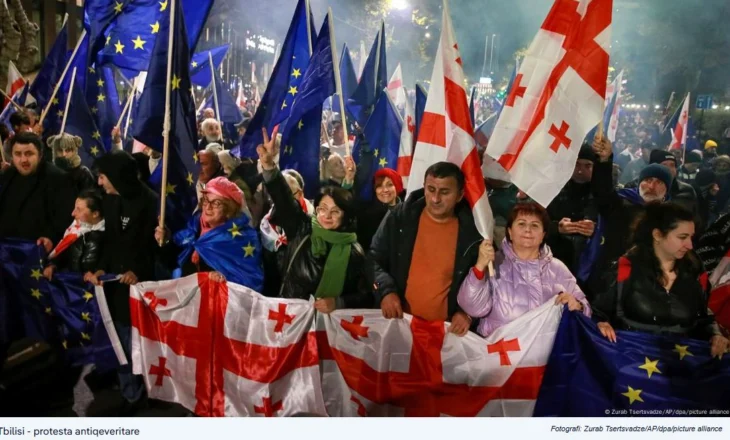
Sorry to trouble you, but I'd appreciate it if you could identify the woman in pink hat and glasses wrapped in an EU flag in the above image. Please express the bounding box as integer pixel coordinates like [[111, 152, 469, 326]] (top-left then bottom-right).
[[155, 177, 264, 292]]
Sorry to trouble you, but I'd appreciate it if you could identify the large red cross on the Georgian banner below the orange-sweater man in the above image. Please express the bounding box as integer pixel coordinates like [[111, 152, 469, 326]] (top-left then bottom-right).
[[317, 318, 545, 417]]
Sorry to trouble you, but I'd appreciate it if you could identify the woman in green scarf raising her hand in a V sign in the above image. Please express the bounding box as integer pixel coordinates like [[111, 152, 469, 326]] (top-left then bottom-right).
[[257, 129, 373, 313]]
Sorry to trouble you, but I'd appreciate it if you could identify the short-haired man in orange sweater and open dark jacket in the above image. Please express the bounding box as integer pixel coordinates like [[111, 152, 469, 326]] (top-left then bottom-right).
[[367, 162, 482, 336]]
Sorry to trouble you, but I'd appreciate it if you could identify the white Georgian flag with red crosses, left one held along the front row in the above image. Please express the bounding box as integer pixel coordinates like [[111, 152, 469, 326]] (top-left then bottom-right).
[[130, 273, 326, 417]]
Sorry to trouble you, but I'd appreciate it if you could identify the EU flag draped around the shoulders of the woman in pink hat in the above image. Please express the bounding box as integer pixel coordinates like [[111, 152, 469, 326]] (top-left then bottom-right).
[[173, 213, 264, 292]]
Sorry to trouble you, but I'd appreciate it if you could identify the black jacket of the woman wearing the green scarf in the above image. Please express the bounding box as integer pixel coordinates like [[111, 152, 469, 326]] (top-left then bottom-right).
[[264, 169, 373, 309]]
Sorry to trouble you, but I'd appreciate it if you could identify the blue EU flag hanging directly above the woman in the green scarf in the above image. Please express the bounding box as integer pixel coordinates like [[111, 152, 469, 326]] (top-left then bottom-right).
[[279, 16, 336, 197]]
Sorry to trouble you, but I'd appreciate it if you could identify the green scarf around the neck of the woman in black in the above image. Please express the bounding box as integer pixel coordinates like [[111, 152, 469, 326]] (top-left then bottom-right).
[[311, 217, 357, 298]]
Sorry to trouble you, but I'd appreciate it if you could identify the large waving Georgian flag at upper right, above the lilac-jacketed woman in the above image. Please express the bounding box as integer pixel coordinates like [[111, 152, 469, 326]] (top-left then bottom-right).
[[487, 0, 613, 206]]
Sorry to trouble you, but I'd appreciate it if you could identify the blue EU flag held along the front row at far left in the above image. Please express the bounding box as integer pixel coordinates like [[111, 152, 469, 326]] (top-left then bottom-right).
[[0, 239, 118, 370]]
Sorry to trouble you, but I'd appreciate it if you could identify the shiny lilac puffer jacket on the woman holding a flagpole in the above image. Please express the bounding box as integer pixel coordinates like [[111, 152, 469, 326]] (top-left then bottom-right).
[[458, 239, 591, 337]]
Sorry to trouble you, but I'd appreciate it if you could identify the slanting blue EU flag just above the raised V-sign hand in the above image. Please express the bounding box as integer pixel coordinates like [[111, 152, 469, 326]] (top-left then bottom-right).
[[232, 0, 317, 157]]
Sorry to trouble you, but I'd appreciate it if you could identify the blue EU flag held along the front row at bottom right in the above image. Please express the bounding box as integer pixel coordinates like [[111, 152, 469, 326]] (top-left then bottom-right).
[[534, 308, 730, 417]]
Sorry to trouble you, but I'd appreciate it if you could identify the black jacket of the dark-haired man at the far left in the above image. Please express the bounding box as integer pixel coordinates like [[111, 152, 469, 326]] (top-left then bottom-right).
[[0, 160, 76, 244]]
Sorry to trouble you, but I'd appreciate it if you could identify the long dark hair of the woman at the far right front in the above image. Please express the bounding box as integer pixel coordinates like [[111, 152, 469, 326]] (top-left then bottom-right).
[[626, 202, 701, 285]]
